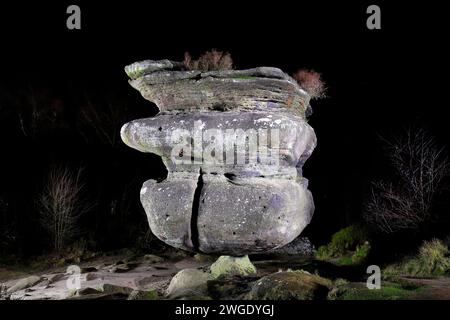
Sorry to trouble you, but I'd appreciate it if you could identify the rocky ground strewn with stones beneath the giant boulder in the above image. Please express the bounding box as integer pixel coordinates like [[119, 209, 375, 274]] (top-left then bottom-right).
[[0, 245, 450, 300]]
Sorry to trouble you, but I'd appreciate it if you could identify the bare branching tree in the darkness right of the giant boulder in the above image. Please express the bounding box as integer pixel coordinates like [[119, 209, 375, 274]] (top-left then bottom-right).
[[364, 128, 449, 233]]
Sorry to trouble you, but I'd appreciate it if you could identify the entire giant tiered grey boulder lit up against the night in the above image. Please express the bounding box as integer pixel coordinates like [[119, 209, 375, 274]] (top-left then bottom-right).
[[121, 60, 316, 256]]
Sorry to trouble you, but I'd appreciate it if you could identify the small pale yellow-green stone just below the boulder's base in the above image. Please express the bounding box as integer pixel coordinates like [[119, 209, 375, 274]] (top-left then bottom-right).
[[210, 256, 256, 279]]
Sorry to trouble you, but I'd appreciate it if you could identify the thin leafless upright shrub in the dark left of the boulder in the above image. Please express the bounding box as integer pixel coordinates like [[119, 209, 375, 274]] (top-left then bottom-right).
[[38, 167, 92, 251]]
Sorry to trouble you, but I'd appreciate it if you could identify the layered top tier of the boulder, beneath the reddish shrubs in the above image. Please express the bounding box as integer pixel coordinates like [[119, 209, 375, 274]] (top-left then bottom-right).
[[125, 60, 309, 114]]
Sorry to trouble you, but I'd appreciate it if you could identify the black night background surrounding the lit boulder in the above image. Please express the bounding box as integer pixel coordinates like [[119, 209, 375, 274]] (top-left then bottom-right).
[[0, 1, 450, 254]]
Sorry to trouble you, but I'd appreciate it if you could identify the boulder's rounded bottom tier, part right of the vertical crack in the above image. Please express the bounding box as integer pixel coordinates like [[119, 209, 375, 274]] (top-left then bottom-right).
[[197, 174, 312, 256]]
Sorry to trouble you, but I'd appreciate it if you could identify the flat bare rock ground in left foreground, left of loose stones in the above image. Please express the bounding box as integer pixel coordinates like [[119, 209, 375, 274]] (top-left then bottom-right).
[[0, 250, 210, 300]]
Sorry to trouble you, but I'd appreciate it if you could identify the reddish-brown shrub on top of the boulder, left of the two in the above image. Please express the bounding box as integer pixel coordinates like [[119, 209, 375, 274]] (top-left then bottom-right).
[[183, 49, 233, 71]]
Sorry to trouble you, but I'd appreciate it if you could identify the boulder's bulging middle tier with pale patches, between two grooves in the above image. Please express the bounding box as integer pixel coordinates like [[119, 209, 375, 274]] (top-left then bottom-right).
[[121, 111, 316, 177]]
